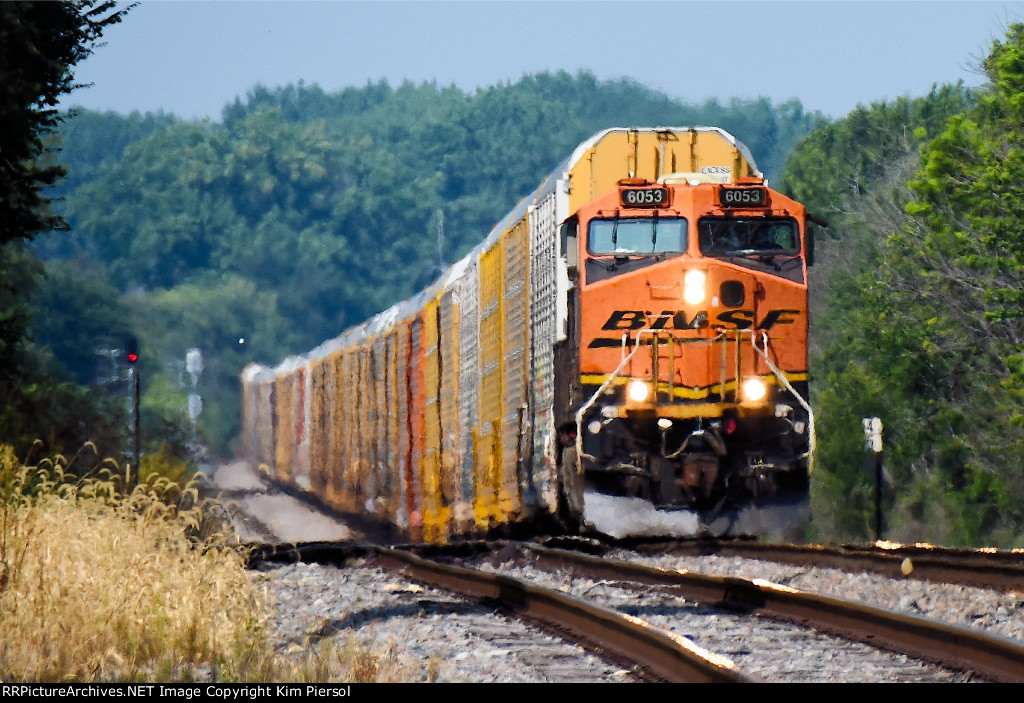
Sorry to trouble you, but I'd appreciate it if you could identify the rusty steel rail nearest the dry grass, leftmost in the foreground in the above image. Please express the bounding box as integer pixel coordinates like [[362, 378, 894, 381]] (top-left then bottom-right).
[[373, 547, 762, 684]]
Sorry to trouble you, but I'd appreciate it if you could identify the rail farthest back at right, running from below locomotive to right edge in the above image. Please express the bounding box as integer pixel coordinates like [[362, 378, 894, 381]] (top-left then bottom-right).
[[630, 541, 1024, 590]]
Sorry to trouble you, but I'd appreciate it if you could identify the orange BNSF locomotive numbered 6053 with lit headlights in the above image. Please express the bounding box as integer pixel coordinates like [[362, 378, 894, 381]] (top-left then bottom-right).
[[556, 166, 813, 534]]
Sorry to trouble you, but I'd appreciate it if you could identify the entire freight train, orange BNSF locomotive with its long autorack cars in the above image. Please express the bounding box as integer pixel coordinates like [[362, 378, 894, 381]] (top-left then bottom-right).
[[242, 127, 814, 542]]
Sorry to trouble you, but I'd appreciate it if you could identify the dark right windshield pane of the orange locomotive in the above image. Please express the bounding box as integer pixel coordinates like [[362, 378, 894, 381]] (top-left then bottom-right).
[[697, 217, 800, 256]]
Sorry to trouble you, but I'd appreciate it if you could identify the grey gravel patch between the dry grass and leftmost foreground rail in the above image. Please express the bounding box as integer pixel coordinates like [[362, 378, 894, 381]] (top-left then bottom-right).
[[255, 564, 637, 683]]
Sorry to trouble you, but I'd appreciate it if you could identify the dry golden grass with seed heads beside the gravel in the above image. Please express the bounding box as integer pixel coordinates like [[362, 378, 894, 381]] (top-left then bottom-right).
[[0, 446, 423, 682]]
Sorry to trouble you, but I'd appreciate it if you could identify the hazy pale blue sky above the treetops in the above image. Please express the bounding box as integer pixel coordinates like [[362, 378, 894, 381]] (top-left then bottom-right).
[[63, 0, 1024, 119]]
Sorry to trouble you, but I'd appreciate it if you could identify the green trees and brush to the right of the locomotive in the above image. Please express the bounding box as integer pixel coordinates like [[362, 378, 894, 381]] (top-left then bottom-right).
[[781, 25, 1024, 546]]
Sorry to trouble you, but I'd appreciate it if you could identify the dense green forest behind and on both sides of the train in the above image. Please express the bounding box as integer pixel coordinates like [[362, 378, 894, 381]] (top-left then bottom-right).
[[16, 5, 1024, 546]]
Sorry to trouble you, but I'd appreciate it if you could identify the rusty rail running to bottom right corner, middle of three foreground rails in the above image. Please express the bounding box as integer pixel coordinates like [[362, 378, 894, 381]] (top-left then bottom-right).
[[524, 544, 1024, 682]]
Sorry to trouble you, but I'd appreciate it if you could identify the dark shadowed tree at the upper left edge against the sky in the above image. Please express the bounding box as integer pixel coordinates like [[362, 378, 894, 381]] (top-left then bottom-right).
[[0, 0, 127, 462]]
